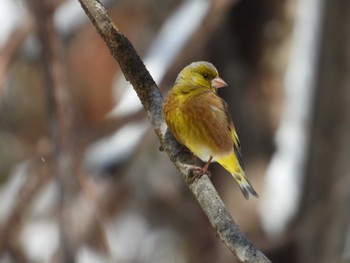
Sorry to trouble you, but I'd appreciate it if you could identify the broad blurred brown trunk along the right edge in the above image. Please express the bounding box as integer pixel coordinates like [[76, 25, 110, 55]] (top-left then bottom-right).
[[297, 1, 350, 263]]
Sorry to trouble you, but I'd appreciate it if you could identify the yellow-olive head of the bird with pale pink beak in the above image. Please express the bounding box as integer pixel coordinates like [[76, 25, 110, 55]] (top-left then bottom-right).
[[176, 61, 227, 92]]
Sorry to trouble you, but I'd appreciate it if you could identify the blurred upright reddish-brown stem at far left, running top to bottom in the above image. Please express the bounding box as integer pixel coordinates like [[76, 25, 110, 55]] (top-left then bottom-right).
[[30, 0, 76, 262]]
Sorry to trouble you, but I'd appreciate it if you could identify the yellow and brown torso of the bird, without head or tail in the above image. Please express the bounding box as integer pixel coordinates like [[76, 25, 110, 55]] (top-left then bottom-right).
[[164, 93, 233, 161]]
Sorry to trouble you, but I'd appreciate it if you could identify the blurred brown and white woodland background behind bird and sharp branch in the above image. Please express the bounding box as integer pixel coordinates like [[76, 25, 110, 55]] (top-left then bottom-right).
[[0, 0, 350, 263]]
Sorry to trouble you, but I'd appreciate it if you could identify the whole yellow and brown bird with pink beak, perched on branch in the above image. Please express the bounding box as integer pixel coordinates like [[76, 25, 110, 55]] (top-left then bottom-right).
[[162, 61, 258, 199]]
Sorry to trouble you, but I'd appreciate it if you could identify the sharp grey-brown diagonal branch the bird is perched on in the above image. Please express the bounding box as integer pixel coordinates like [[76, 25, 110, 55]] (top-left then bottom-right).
[[79, 0, 270, 262]]
